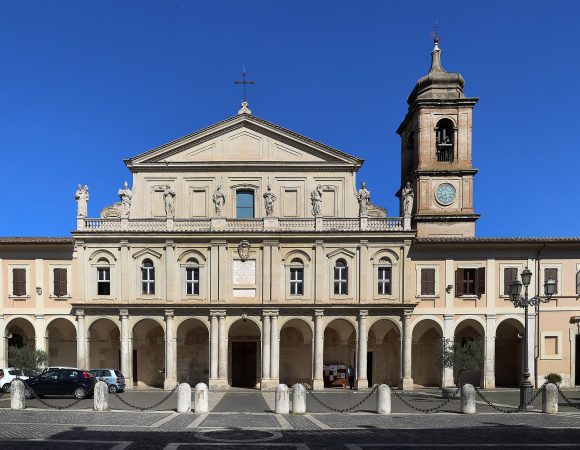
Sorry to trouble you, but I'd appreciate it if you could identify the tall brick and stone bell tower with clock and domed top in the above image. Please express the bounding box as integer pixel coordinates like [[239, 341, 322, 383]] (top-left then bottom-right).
[[397, 37, 479, 237]]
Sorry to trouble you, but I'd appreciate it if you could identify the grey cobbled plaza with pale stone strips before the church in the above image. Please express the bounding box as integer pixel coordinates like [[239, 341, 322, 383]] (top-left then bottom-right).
[[0, 390, 580, 450]]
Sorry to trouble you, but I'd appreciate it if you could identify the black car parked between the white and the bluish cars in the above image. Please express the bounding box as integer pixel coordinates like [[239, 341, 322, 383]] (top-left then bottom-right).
[[24, 368, 96, 398]]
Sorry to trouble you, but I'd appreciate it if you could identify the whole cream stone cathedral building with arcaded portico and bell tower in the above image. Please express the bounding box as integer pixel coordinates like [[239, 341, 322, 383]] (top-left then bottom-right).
[[0, 43, 580, 389]]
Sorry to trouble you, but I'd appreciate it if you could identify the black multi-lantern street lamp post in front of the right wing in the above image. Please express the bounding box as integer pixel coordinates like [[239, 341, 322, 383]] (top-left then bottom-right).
[[510, 267, 556, 408]]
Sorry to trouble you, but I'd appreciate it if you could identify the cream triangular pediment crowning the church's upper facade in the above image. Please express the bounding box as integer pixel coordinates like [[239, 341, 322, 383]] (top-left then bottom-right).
[[125, 114, 363, 171]]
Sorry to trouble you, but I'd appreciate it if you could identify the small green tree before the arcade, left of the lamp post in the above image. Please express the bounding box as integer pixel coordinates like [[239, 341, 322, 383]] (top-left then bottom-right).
[[436, 338, 485, 384]]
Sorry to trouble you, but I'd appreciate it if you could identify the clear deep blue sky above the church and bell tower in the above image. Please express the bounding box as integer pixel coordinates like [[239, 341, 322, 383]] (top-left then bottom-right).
[[0, 0, 580, 236]]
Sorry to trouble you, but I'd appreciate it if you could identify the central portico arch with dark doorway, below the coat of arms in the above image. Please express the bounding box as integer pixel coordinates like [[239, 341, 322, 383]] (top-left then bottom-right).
[[228, 319, 261, 388]]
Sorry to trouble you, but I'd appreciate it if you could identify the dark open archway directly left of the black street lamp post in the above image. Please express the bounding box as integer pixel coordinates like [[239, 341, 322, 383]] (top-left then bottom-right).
[[495, 319, 524, 387]]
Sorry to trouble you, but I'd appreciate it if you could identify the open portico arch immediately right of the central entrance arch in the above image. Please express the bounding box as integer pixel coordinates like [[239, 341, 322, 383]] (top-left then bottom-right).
[[280, 319, 312, 386]]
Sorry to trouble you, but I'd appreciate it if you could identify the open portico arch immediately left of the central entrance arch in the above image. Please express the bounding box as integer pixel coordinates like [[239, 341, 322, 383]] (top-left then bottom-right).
[[177, 319, 209, 386]]
